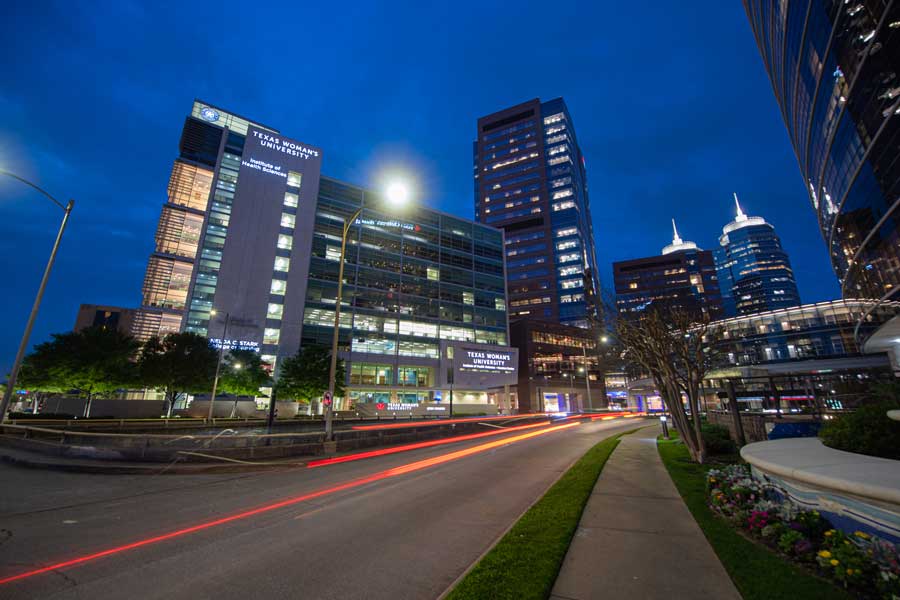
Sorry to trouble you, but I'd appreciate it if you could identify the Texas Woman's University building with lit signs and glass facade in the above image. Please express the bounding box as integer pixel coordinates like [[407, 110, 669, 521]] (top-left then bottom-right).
[[134, 100, 518, 414]]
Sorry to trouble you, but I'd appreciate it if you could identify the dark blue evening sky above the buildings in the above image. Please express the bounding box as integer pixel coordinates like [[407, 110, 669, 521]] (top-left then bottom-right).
[[0, 0, 839, 369]]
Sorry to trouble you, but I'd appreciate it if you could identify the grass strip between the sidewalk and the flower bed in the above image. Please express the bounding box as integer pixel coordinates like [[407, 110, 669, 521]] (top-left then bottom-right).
[[658, 439, 852, 600]]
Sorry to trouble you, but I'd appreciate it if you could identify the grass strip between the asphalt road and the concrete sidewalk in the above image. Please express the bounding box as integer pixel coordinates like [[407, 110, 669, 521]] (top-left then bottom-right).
[[447, 429, 637, 600]]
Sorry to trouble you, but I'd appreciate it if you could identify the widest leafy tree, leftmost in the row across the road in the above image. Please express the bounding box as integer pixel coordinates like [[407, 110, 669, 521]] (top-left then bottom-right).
[[16, 327, 140, 417]]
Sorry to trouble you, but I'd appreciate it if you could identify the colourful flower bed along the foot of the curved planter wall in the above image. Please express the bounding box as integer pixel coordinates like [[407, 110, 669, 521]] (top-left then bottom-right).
[[706, 465, 900, 600]]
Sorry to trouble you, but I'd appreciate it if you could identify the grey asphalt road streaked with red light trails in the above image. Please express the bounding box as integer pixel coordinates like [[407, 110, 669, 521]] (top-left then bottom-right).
[[0, 419, 640, 600]]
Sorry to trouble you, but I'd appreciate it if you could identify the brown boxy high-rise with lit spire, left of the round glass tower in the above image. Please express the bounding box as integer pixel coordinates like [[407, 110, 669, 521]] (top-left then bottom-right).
[[613, 219, 722, 320]]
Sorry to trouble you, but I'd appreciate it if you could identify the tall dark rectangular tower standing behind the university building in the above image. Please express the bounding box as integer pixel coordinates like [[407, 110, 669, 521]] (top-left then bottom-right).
[[474, 98, 600, 327]]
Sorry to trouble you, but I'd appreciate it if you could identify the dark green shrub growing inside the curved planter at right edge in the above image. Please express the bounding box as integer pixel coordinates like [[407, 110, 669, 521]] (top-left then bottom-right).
[[819, 399, 900, 460]]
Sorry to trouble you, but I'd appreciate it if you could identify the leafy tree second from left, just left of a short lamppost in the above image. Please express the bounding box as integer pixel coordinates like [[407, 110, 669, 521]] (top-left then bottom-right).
[[138, 333, 218, 417]]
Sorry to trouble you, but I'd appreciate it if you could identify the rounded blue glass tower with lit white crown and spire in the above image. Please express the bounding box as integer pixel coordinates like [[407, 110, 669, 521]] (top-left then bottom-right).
[[714, 194, 800, 317]]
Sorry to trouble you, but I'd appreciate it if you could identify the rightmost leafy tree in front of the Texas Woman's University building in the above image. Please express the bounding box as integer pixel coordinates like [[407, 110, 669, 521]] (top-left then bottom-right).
[[277, 344, 344, 402]]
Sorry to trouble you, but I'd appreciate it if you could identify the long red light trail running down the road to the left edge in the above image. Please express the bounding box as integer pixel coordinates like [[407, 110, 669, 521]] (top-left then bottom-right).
[[0, 423, 579, 585]]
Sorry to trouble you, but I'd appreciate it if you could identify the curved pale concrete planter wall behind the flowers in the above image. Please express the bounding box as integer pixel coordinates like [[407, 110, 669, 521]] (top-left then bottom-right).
[[741, 438, 900, 544]]
